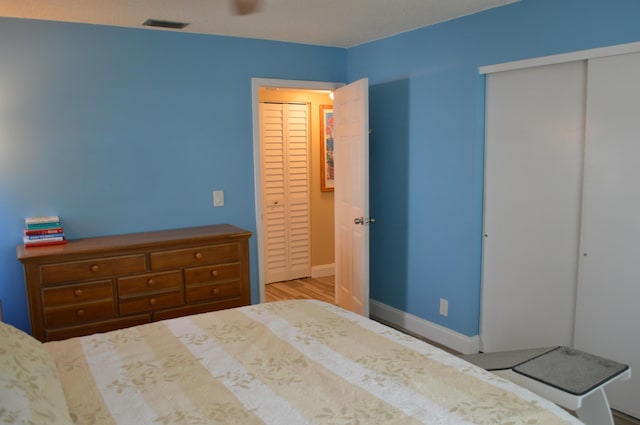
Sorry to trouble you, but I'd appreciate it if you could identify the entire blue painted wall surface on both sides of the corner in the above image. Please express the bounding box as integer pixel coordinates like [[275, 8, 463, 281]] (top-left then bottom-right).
[[0, 0, 640, 336]]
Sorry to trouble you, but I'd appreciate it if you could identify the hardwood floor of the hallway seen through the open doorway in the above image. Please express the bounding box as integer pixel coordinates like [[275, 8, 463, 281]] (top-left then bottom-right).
[[265, 276, 335, 304]]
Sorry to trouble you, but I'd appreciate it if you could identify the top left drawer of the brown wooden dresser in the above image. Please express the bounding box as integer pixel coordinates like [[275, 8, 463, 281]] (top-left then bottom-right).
[[40, 254, 146, 285]]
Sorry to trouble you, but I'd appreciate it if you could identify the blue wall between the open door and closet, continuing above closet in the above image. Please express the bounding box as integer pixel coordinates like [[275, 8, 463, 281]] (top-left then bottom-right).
[[358, 0, 640, 336]]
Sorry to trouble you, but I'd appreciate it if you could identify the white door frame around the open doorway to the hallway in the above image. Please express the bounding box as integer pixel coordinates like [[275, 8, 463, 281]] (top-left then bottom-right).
[[251, 78, 344, 303]]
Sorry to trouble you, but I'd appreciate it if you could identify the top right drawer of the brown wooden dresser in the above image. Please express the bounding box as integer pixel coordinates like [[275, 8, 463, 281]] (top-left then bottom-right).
[[150, 243, 240, 270]]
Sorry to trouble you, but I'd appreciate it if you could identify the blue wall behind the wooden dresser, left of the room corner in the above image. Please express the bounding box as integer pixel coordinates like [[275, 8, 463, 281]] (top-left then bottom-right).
[[0, 19, 346, 329]]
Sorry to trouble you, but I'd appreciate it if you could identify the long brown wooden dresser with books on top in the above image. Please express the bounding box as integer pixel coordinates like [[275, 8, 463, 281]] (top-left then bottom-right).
[[16, 224, 251, 341]]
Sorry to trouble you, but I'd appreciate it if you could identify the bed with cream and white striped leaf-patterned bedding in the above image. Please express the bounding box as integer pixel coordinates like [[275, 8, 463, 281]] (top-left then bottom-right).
[[0, 300, 581, 425]]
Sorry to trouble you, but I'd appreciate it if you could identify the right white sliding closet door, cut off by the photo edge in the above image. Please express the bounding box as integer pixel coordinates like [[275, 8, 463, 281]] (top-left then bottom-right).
[[575, 53, 640, 417]]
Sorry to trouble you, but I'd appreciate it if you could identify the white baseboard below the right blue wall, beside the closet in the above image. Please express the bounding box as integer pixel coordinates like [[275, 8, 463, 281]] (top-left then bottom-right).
[[369, 300, 480, 354]]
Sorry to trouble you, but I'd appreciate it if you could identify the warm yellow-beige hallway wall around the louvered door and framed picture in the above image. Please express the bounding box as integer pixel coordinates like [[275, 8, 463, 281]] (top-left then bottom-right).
[[259, 88, 335, 267]]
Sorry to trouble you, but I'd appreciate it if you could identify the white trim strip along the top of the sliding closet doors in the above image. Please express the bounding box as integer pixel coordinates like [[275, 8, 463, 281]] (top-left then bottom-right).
[[480, 42, 640, 74]]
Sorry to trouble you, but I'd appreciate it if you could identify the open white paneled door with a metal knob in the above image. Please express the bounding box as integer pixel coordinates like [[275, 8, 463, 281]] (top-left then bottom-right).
[[333, 78, 370, 317]]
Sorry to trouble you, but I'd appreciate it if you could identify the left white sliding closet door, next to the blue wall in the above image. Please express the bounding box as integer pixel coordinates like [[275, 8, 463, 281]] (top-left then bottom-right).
[[480, 61, 586, 351]]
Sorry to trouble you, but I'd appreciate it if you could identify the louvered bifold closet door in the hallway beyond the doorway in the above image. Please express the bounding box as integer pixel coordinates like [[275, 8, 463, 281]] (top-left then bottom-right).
[[260, 103, 311, 283]]
